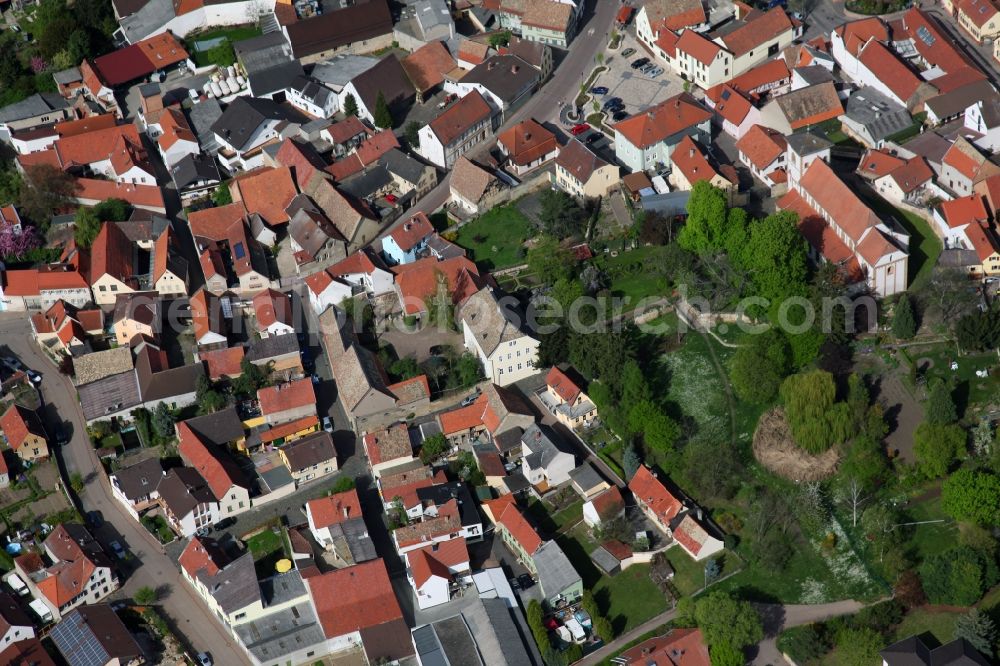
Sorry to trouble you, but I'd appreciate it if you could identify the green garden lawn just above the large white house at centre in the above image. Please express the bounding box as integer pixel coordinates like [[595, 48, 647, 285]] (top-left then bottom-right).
[[455, 204, 534, 270]]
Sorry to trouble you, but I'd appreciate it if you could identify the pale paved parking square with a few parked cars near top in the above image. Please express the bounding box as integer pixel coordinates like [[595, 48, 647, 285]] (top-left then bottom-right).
[[585, 32, 684, 120]]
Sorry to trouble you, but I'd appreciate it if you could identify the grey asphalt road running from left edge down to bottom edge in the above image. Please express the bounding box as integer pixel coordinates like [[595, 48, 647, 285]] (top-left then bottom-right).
[[0, 313, 249, 666]]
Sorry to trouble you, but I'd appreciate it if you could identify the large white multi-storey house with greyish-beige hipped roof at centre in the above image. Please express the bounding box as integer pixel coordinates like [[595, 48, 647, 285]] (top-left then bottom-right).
[[458, 287, 538, 386]]
